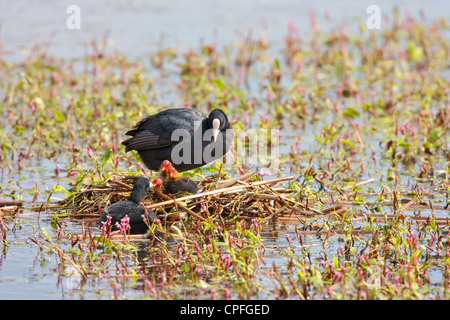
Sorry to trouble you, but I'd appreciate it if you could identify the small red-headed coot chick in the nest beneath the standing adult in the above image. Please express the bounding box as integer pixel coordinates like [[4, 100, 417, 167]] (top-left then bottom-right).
[[160, 160, 199, 194]]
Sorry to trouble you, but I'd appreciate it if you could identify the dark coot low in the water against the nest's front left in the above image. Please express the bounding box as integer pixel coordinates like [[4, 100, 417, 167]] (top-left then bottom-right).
[[100, 177, 162, 234]]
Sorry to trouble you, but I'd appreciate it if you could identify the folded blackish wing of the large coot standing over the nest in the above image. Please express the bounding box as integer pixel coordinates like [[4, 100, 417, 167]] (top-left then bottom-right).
[[122, 108, 206, 152]]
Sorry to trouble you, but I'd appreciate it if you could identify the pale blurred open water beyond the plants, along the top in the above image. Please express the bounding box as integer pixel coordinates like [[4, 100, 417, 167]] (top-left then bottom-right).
[[0, 0, 450, 59]]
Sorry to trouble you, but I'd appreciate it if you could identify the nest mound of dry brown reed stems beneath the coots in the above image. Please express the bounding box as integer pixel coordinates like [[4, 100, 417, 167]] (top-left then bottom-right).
[[58, 173, 298, 222]]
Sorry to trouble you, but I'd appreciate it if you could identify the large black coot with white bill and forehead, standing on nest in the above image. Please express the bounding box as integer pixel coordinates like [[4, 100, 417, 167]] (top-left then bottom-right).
[[122, 108, 234, 171]]
